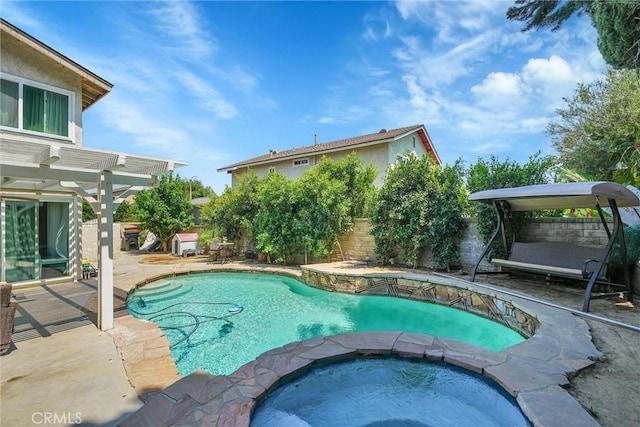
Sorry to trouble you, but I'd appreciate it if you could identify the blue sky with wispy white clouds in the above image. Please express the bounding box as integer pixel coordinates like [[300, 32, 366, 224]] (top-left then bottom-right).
[[0, 0, 606, 194]]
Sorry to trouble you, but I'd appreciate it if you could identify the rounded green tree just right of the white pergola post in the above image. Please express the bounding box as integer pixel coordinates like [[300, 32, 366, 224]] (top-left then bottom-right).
[[135, 173, 194, 250]]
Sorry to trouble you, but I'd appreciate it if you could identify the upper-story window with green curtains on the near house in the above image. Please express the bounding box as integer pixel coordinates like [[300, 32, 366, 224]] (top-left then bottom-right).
[[0, 76, 74, 137]]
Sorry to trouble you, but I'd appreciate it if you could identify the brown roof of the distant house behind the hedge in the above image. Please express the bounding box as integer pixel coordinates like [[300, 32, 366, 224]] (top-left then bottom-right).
[[217, 125, 440, 173]]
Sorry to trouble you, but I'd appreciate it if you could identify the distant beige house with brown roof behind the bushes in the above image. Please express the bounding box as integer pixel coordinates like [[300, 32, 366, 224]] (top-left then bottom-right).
[[218, 125, 440, 187]]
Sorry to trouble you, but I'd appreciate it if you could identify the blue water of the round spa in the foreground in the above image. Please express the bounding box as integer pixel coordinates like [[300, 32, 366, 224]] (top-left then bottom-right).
[[251, 359, 530, 427]]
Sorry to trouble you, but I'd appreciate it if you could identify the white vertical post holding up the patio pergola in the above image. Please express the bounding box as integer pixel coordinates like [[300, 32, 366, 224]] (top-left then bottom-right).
[[98, 171, 113, 331]]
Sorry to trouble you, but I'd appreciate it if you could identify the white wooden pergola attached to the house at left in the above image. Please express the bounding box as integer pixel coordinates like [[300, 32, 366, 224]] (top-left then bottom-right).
[[0, 139, 186, 330]]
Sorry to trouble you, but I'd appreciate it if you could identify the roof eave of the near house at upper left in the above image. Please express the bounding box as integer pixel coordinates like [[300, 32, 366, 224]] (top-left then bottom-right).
[[0, 18, 113, 110]]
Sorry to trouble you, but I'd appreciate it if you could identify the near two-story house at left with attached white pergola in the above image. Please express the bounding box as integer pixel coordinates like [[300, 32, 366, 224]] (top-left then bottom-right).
[[0, 18, 185, 329]]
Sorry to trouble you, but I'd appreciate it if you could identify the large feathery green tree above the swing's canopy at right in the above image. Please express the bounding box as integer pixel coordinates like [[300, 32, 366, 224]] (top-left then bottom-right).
[[547, 70, 640, 185]]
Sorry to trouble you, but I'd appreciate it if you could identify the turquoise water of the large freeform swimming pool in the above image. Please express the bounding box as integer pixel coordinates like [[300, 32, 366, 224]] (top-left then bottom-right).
[[127, 273, 524, 375]]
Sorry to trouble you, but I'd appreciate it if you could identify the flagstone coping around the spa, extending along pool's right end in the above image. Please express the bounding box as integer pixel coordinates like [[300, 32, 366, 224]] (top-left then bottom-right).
[[121, 269, 603, 426]]
